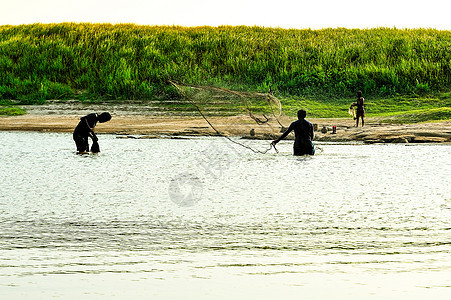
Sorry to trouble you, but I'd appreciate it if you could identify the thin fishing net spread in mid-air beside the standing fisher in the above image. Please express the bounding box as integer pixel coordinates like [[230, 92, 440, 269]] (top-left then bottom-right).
[[170, 81, 289, 153]]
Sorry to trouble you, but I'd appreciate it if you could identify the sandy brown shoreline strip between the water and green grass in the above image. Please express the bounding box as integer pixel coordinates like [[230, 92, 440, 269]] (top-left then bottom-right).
[[0, 103, 451, 143]]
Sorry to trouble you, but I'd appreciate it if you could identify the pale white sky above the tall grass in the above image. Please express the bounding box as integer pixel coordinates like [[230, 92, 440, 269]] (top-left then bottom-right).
[[0, 0, 451, 30]]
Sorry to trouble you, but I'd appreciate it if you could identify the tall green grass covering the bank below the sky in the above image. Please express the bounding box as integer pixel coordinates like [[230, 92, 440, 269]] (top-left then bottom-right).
[[0, 23, 451, 103]]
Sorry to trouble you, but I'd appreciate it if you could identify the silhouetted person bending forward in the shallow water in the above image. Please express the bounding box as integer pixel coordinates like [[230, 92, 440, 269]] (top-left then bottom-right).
[[73, 112, 111, 153]]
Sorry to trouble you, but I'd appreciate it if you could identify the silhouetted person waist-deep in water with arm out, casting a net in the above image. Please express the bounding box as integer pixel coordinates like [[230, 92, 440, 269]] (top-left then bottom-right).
[[271, 109, 315, 156]]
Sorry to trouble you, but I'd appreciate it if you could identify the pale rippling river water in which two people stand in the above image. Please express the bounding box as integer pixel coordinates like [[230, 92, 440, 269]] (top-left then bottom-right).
[[0, 132, 451, 299]]
